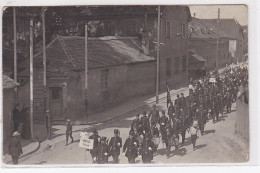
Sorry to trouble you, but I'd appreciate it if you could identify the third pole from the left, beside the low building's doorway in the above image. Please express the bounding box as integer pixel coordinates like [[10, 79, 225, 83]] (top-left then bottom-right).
[[42, 8, 48, 114]]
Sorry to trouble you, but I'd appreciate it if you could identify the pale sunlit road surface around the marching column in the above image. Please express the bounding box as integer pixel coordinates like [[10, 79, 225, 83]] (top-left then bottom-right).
[[20, 101, 248, 164]]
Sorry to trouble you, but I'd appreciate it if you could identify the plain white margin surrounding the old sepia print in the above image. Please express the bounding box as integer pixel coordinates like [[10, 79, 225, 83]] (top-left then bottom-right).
[[0, 0, 260, 172]]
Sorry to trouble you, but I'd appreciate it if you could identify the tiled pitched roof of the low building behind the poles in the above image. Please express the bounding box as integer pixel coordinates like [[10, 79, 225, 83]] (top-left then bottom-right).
[[19, 36, 155, 76]]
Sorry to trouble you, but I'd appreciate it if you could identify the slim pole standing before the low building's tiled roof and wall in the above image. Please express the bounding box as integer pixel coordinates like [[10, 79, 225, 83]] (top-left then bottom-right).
[[85, 24, 88, 121]]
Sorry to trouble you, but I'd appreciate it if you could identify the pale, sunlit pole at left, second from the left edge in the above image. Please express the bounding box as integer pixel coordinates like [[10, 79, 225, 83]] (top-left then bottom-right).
[[30, 19, 34, 139]]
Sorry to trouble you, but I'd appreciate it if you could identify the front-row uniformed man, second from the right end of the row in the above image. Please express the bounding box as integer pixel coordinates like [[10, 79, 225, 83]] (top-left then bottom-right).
[[123, 131, 139, 163]]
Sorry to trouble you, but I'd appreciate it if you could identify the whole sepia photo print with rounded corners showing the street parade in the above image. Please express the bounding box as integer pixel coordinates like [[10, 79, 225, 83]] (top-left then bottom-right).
[[2, 4, 249, 165]]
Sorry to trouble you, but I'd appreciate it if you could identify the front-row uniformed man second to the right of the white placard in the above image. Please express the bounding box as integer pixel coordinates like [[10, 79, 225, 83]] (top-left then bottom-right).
[[97, 137, 110, 164]]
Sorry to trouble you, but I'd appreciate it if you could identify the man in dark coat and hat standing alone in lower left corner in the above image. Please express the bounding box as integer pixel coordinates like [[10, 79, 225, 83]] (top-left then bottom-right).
[[9, 131, 23, 165]]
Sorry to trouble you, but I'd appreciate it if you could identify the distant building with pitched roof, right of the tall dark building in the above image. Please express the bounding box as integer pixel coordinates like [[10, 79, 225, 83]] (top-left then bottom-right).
[[189, 18, 234, 69]]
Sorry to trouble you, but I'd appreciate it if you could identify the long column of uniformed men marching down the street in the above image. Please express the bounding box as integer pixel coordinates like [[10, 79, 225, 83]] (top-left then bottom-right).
[[87, 66, 248, 163]]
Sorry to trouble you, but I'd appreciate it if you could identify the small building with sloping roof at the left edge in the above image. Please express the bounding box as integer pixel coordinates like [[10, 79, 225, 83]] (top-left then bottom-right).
[[2, 75, 19, 153]]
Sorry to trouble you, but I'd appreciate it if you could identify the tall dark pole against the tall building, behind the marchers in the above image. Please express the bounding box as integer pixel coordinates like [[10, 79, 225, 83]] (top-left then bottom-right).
[[156, 5, 161, 104]]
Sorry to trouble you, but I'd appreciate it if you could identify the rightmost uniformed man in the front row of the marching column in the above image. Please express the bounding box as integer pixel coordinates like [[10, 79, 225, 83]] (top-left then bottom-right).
[[139, 134, 154, 163]]
